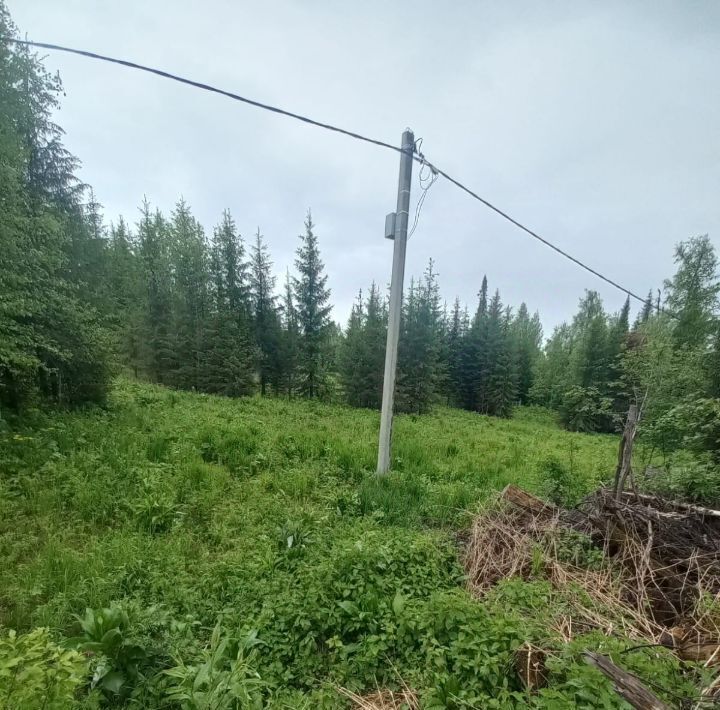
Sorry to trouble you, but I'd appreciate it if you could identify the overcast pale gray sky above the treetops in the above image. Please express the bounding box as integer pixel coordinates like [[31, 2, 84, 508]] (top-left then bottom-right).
[[9, 0, 720, 334]]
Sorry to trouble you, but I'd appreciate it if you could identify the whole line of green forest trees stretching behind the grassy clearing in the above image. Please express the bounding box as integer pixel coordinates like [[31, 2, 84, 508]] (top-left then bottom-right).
[[0, 4, 720, 478]]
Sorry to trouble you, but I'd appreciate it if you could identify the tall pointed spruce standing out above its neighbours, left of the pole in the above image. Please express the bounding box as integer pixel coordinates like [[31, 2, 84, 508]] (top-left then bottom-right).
[[294, 210, 331, 398]]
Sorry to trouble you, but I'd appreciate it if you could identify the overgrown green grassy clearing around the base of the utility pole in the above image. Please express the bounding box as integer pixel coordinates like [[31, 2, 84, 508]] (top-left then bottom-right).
[[0, 381, 696, 708]]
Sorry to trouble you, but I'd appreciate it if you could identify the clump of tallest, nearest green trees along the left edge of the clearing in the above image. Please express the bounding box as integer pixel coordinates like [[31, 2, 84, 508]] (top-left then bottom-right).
[[0, 12, 108, 407]]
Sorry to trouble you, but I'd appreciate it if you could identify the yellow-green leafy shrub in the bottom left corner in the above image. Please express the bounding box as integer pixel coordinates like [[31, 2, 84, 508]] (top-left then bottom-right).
[[0, 629, 88, 710]]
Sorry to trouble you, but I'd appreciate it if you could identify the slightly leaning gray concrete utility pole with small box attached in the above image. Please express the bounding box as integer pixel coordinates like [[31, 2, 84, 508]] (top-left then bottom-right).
[[377, 129, 415, 475]]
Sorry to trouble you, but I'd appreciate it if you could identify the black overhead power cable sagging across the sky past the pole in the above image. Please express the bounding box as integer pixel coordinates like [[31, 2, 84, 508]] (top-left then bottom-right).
[[0, 37, 660, 303]]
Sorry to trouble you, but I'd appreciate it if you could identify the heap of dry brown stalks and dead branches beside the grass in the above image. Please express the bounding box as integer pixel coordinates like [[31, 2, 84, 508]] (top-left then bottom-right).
[[465, 485, 720, 704]]
